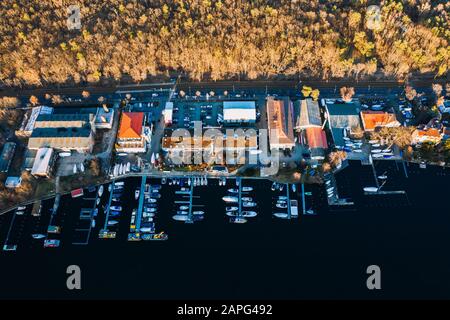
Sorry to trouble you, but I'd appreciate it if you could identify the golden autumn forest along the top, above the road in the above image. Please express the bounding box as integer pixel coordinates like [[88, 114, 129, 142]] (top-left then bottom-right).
[[0, 0, 450, 86]]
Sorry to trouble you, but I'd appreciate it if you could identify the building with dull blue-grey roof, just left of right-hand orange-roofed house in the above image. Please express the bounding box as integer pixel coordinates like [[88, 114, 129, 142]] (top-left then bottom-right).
[[324, 99, 361, 146]]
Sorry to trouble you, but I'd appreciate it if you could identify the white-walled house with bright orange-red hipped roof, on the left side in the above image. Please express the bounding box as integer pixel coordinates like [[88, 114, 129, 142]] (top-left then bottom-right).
[[116, 112, 147, 153]]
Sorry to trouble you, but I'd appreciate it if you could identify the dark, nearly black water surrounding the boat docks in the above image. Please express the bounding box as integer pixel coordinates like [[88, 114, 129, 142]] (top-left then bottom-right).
[[0, 162, 450, 299]]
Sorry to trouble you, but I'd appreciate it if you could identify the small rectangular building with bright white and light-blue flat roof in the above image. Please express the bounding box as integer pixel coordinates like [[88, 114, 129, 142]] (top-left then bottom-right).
[[223, 101, 256, 124]]
